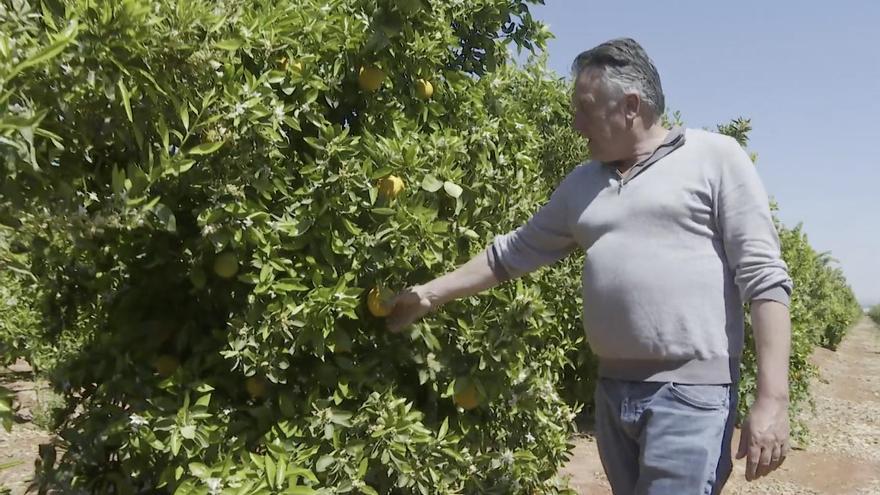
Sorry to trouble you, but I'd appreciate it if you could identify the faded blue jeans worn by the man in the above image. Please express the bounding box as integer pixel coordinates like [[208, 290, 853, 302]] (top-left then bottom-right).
[[595, 378, 737, 495]]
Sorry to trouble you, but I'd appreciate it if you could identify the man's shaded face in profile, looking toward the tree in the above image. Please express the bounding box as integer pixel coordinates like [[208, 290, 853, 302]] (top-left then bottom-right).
[[572, 67, 633, 162]]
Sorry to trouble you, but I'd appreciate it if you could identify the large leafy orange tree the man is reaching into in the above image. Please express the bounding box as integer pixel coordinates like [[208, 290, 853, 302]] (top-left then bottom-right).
[[0, 0, 585, 494]]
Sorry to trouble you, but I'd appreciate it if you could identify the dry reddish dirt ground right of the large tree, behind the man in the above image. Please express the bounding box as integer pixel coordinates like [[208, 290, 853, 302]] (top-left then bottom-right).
[[563, 318, 880, 495]]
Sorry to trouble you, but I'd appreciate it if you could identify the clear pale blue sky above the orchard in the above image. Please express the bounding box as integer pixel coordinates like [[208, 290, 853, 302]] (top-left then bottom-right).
[[532, 0, 880, 304]]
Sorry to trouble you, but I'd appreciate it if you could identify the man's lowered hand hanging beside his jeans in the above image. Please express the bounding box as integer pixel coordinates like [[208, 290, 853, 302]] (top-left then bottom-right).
[[736, 397, 789, 481]]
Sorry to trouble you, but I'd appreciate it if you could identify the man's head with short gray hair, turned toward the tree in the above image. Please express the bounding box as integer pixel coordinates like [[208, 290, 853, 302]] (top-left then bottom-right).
[[571, 38, 666, 162]]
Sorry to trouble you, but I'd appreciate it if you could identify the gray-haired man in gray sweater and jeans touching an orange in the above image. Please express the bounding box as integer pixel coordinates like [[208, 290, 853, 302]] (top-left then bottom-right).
[[388, 39, 792, 495]]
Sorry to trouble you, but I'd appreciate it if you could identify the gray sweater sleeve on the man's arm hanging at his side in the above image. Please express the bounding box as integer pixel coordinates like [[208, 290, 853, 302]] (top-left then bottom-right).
[[715, 139, 793, 306]]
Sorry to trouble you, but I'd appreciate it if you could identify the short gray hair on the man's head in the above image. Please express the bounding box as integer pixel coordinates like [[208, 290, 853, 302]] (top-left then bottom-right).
[[571, 38, 666, 118]]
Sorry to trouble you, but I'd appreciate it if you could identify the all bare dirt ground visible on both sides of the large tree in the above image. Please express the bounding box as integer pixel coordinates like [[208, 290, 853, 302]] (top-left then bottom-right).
[[0, 318, 880, 495]]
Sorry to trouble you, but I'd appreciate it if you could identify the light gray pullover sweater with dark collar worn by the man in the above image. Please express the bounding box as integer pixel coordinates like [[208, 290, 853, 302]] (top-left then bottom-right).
[[488, 128, 792, 384]]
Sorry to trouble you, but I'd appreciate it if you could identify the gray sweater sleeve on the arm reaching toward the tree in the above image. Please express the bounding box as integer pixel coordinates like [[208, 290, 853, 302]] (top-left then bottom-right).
[[487, 177, 577, 282]]
